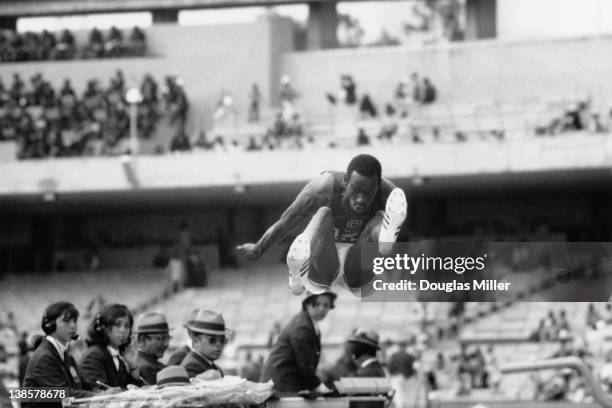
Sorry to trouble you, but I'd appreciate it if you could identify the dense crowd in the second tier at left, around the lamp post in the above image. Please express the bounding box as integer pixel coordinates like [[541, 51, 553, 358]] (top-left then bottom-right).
[[0, 70, 189, 159]]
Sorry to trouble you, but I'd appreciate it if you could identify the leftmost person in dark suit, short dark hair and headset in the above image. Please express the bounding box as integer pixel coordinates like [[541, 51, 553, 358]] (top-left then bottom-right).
[[21, 302, 94, 408]]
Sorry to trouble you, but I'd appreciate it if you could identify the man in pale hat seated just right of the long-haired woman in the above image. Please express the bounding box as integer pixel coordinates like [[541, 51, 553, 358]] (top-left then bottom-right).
[[134, 312, 170, 385]]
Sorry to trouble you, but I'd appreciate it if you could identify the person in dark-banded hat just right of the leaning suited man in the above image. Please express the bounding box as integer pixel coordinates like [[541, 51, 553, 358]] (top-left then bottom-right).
[[348, 330, 386, 377]]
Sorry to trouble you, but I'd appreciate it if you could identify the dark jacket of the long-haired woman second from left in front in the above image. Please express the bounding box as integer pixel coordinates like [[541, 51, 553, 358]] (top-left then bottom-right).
[[81, 344, 142, 390]]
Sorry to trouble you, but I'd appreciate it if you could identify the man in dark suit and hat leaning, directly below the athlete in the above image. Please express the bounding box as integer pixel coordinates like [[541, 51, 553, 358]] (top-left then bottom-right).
[[261, 292, 336, 396]]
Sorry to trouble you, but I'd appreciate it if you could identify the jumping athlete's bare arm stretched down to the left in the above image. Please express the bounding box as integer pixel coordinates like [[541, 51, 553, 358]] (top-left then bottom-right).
[[236, 173, 334, 259]]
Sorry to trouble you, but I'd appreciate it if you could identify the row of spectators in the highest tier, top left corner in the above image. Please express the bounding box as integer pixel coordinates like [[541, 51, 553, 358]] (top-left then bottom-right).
[[0, 26, 147, 63]]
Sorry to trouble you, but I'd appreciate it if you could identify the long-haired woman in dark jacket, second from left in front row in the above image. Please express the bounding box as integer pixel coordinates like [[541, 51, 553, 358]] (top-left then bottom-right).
[[80, 304, 142, 389]]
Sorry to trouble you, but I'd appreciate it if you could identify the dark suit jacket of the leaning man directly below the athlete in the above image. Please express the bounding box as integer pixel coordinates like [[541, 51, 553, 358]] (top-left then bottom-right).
[[261, 311, 321, 393]]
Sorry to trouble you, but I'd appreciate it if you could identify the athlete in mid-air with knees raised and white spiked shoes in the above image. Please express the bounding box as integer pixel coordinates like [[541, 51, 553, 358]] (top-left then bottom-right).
[[237, 154, 407, 295]]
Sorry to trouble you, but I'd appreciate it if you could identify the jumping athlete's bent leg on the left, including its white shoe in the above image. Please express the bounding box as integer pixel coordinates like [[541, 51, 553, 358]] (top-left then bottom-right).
[[287, 207, 338, 295]]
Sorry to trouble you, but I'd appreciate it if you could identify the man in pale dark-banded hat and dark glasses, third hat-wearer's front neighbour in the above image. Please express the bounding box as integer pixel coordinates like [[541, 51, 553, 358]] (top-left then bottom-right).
[[181, 310, 229, 379]]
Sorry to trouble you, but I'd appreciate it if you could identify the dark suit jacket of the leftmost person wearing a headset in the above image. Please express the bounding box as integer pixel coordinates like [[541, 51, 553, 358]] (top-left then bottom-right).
[[21, 339, 94, 408]]
